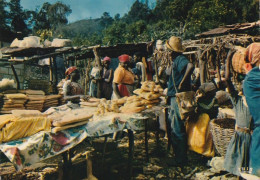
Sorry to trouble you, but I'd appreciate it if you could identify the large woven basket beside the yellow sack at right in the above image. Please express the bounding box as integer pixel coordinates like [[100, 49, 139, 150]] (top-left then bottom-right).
[[210, 118, 235, 157]]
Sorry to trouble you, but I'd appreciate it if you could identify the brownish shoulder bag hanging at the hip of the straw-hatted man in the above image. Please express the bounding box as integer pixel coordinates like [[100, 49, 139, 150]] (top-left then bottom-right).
[[175, 91, 196, 120]]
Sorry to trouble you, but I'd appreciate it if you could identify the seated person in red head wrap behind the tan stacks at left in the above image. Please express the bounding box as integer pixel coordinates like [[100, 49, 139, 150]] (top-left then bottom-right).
[[63, 66, 86, 102]]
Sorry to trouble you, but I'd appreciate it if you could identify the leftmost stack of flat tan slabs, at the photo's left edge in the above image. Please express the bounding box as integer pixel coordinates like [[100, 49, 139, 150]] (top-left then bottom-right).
[[0, 93, 27, 114]]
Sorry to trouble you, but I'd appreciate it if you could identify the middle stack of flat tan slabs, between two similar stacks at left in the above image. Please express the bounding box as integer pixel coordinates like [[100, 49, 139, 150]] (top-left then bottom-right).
[[24, 90, 45, 111]]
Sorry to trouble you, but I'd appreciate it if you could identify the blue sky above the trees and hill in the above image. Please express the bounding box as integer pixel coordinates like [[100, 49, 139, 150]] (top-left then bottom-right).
[[21, 0, 156, 23]]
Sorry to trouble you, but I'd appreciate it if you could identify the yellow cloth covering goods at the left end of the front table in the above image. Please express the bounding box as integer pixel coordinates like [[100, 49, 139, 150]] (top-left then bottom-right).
[[0, 110, 51, 143]]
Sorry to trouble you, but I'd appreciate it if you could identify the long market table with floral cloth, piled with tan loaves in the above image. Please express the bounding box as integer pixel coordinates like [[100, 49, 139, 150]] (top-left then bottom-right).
[[0, 79, 165, 180]]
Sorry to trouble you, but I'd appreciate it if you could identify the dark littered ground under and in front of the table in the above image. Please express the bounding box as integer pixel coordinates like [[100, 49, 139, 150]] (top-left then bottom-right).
[[0, 132, 236, 180]]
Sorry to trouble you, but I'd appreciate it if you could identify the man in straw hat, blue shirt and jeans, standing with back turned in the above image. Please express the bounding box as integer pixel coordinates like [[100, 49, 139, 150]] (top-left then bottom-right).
[[166, 36, 194, 166]]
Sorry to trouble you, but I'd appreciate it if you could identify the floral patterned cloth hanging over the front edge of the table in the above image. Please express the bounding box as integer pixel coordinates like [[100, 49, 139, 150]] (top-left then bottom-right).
[[0, 106, 164, 170]]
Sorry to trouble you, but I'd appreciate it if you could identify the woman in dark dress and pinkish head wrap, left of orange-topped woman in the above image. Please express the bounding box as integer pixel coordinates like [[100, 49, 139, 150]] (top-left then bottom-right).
[[101, 56, 113, 100]]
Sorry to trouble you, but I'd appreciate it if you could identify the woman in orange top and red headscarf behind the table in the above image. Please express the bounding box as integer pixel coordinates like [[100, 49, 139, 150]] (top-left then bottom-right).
[[112, 54, 134, 99]]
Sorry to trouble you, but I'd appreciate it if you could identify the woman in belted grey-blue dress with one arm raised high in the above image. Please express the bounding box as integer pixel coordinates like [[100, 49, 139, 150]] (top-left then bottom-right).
[[224, 51, 252, 176]]
